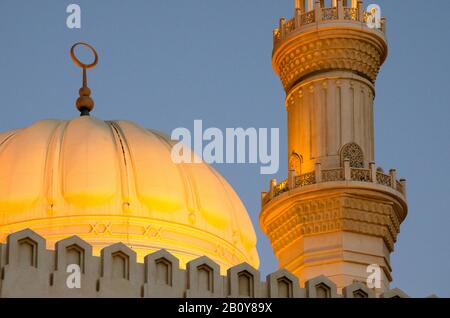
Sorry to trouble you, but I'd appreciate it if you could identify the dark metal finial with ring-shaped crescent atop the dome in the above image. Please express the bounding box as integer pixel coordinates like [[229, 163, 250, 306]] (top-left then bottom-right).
[[70, 42, 98, 116]]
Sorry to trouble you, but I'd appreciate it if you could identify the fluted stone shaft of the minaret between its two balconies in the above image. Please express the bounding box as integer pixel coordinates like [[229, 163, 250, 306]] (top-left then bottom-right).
[[286, 72, 374, 173]]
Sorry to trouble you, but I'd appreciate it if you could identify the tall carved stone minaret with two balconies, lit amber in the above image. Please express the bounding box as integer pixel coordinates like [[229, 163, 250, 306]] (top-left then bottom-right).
[[260, 0, 407, 293]]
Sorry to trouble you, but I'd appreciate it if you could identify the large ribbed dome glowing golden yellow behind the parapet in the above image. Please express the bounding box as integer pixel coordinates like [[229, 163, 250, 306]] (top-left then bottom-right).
[[0, 116, 259, 270]]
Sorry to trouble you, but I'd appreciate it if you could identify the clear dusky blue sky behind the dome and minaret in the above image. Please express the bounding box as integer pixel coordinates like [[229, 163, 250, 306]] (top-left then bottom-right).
[[0, 0, 450, 297]]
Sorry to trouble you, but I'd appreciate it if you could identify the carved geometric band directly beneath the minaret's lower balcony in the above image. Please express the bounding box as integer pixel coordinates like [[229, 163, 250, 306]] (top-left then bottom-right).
[[265, 196, 400, 251]]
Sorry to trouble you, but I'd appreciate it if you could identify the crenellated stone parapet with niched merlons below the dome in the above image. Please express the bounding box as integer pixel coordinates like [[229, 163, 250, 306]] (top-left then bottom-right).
[[0, 229, 418, 298]]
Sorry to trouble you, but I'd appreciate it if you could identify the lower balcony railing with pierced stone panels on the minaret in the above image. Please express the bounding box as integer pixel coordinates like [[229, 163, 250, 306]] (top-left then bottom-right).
[[262, 160, 406, 206]]
